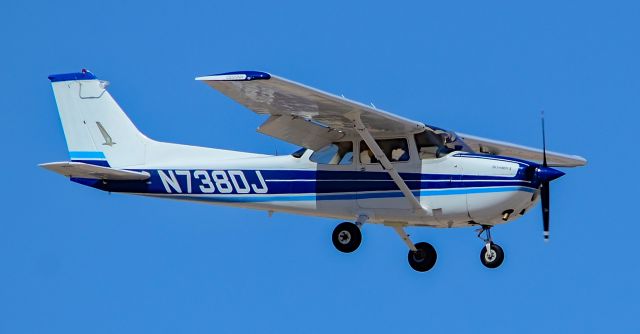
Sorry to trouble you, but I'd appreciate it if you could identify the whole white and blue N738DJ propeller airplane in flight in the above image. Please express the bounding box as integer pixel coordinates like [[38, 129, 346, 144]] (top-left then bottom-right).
[[40, 69, 587, 272]]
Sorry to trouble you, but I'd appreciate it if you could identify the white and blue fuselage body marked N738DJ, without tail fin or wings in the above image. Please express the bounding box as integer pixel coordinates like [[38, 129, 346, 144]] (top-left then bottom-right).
[[79, 150, 537, 227]]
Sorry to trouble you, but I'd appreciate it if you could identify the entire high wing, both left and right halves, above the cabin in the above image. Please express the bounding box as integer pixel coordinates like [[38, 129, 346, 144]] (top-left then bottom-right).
[[196, 71, 586, 167]]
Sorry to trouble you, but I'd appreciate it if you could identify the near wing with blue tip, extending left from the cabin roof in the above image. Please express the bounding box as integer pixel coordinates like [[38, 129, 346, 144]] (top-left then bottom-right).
[[196, 71, 425, 150]]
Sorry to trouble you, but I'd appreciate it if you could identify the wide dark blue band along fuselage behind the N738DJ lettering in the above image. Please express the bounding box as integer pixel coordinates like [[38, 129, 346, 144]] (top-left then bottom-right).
[[74, 170, 537, 196]]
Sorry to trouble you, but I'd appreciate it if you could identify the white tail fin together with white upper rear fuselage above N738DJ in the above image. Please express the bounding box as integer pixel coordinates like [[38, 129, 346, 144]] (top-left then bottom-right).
[[43, 70, 264, 175]]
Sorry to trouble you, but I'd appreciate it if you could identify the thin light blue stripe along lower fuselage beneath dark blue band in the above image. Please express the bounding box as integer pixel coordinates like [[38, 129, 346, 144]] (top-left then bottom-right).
[[162, 187, 535, 203]]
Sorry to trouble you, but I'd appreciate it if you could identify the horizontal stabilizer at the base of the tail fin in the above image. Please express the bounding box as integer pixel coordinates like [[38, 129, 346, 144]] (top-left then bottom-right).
[[40, 161, 149, 181]]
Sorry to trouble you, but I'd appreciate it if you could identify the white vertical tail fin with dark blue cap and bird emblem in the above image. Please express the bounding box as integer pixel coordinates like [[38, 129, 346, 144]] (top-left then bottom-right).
[[49, 70, 150, 168]]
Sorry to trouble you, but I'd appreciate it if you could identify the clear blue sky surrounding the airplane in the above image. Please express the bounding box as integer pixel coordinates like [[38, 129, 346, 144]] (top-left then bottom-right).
[[0, 1, 640, 333]]
